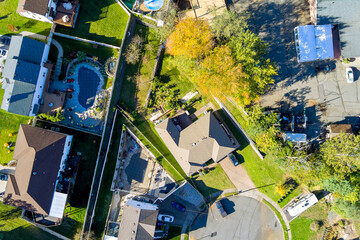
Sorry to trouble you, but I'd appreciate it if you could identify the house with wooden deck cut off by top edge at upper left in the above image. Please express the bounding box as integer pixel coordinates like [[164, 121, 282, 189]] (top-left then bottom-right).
[[16, 0, 80, 27]]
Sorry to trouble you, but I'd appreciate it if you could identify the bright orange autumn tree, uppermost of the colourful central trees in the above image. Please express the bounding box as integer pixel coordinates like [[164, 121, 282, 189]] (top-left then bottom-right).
[[166, 17, 214, 58]]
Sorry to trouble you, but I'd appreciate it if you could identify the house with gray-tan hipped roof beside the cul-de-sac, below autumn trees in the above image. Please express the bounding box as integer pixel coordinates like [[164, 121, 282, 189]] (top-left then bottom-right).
[[155, 112, 238, 175]]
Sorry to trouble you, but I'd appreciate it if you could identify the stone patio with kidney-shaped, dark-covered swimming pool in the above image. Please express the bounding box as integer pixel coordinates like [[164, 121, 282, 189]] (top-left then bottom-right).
[[49, 57, 110, 133]]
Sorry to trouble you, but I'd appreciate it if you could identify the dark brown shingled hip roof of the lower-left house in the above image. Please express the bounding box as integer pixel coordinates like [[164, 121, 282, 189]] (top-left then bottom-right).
[[4, 124, 67, 215]]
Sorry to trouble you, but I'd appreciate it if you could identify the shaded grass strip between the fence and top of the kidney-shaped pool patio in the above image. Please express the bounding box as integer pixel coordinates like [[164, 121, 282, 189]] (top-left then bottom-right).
[[49, 36, 119, 88]]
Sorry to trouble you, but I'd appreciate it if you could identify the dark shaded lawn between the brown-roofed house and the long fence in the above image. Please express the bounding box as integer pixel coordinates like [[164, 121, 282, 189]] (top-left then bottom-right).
[[37, 121, 101, 239]]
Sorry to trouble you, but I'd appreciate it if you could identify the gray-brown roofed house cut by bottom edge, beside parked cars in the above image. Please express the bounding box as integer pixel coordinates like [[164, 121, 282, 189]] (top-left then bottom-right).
[[116, 199, 159, 240]]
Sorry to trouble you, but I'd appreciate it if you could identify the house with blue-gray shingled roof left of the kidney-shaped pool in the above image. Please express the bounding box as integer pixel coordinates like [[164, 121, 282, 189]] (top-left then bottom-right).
[[1, 36, 49, 116]]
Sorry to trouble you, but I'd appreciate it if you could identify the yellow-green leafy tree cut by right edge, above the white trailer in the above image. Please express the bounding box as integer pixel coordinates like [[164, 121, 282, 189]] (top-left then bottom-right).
[[320, 134, 360, 179]]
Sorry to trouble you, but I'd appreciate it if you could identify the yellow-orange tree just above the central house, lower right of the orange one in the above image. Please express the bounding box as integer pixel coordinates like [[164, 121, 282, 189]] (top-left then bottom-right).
[[195, 46, 248, 96]]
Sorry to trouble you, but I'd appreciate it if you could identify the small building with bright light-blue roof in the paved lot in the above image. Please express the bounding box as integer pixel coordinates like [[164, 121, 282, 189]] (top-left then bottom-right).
[[294, 24, 334, 62]]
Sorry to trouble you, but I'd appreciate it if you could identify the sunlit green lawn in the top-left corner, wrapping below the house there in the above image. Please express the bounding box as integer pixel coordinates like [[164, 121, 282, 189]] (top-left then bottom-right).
[[0, 0, 51, 36]]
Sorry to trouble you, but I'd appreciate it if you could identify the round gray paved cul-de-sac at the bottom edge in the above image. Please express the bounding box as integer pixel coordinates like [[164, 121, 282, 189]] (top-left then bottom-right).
[[189, 196, 284, 240]]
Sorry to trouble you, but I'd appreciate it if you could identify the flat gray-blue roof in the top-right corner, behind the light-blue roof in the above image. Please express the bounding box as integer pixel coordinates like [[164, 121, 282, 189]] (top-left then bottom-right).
[[317, 0, 360, 58]]
